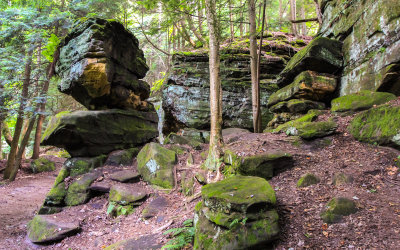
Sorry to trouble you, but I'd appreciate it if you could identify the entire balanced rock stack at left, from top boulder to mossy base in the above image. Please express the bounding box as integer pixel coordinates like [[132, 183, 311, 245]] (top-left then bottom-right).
[[39, 18, 158, 214]]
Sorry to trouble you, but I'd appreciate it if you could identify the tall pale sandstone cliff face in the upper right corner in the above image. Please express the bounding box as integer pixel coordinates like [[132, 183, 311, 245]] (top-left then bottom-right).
[[320, 0, 400, 95]]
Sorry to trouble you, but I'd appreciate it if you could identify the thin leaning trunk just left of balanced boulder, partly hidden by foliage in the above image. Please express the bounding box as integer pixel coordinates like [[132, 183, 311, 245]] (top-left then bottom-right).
[[32, 0, 65, 159]]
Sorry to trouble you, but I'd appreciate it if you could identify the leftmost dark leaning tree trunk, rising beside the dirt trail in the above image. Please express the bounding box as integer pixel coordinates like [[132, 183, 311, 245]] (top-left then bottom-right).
[[4, 49, 33, 181]]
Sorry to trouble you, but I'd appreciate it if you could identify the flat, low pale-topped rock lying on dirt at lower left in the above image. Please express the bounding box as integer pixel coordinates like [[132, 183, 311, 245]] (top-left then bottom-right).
[[27, 215, 80, 244]]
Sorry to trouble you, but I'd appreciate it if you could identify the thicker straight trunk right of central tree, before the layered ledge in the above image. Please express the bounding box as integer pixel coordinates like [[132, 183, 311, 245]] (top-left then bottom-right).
[[248, 0, 261, 133]]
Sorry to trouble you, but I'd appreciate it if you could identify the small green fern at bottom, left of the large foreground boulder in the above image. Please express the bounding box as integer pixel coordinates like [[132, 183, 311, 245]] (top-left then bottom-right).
[[161, 219, 195, 250]]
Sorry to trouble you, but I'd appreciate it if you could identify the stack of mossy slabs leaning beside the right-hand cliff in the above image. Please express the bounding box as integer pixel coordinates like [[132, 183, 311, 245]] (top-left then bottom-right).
[[268, 37, 342, 127]]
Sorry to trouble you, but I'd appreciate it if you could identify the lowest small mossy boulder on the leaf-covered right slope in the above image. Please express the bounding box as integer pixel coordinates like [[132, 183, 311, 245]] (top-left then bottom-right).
[[321, 197, 357, 223]]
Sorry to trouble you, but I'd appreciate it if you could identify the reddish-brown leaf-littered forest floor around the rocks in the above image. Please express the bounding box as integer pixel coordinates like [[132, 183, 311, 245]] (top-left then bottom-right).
[[0, 102, 400, 249]]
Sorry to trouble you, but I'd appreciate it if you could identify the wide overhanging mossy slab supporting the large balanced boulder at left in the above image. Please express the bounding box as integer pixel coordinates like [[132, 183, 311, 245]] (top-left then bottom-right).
[[41, 109, 158, 157]]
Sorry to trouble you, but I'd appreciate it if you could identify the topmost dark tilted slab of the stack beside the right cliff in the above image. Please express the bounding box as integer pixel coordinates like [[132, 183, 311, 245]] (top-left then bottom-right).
[[278, 37, 343, 87]]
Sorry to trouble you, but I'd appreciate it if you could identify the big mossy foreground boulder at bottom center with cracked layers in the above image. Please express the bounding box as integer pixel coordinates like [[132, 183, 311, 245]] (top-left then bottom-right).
[[194, 176, 279, 249]]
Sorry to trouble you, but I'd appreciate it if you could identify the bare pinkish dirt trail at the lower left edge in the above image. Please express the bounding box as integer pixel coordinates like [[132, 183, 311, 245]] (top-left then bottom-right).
[[0, 171, 57, 249]]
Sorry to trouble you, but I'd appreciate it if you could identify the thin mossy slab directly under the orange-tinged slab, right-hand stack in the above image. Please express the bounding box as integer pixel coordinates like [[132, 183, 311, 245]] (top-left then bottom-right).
[[270, 99, 325, 114]]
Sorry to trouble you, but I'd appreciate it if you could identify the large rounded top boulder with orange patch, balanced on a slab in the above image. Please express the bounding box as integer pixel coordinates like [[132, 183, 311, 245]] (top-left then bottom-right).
[[56, 18, 153, 110]]
